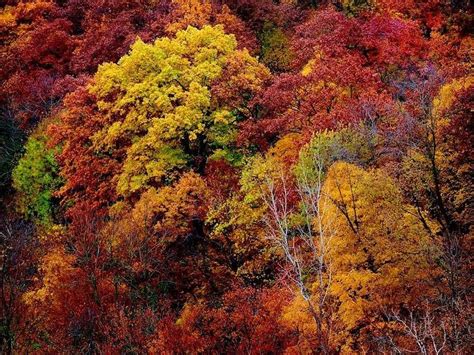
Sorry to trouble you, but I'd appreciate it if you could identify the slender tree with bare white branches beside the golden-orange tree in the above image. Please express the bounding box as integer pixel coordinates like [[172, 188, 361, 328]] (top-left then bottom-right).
[[265, 136, 333, 354]]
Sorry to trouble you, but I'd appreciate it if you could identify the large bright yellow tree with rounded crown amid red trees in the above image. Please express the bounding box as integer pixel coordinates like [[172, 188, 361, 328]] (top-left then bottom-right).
[[90, 26, 268, 196]]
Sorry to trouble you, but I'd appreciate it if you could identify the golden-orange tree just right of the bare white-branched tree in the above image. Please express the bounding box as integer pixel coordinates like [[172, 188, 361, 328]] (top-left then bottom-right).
[[323, 162, 439, 352]]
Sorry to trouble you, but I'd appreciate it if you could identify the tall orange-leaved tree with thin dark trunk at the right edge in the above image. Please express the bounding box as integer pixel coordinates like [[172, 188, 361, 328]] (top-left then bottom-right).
[[400, 72, 472, 349]]
